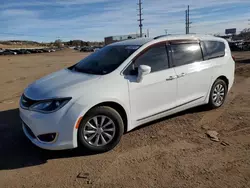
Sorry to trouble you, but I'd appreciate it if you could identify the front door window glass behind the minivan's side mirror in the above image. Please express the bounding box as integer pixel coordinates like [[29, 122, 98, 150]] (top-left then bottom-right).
[[124, 43, 169, 74]]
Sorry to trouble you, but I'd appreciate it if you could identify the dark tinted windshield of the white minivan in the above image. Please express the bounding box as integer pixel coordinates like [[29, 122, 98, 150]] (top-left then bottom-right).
[[74, 45, 140, 75]]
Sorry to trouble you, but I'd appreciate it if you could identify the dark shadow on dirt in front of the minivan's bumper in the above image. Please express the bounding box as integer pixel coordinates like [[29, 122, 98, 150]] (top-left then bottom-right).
[[0, 109, 95, 170]]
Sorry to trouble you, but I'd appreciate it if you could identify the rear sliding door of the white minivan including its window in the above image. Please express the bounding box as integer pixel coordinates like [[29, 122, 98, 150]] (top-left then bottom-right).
[[171, 41, 213, 106]]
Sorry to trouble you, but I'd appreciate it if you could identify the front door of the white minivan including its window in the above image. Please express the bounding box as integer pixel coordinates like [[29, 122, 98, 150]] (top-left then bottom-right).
[[125, 43, 177, 124]]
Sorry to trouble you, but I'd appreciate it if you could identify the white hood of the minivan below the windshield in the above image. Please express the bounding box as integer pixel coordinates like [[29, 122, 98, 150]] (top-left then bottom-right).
[[24, 69, 101, 100]]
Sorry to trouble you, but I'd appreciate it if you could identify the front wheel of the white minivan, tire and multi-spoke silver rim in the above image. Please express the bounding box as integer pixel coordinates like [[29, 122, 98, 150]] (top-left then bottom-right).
[[78, 106, 124, 153]]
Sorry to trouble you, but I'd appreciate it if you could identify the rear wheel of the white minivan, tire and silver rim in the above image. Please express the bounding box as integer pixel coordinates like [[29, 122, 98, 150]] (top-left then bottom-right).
[[208, 79, 228, 109]]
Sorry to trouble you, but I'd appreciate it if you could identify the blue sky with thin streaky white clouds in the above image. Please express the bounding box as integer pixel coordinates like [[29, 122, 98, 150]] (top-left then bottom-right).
[[0, 0, 250, 42]]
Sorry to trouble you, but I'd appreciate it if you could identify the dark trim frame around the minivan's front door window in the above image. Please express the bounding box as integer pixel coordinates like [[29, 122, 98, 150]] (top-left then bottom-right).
[[121, 41, 173, 76]]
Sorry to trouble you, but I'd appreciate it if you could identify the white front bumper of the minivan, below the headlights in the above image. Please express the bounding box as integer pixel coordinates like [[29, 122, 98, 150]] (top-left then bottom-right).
[[19, 102, 83, 150]]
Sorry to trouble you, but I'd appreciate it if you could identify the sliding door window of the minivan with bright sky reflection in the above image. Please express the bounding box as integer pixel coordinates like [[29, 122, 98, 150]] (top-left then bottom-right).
[[171, 44, 203, 66]]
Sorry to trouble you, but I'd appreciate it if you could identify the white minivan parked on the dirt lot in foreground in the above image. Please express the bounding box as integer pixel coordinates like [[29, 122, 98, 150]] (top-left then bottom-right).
[[20, 35, 235, 152]]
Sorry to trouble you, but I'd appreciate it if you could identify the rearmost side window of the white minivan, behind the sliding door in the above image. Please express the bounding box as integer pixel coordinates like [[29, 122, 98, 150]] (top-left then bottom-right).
[[201, 41, 226, 60]]
